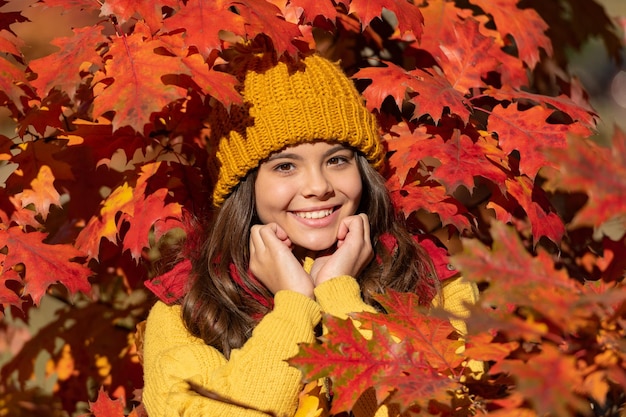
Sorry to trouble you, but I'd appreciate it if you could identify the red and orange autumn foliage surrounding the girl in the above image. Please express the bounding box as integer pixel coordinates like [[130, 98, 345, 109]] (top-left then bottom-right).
[[0, 0, 626, 416]]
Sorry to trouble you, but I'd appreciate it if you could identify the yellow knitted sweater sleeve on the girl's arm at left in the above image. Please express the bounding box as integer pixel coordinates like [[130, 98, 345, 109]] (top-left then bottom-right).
[[143, 291, 321, 417]]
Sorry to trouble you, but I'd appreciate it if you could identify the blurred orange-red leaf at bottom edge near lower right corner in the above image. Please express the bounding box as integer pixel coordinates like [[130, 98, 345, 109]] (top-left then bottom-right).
[[496, 344, 589, 416]]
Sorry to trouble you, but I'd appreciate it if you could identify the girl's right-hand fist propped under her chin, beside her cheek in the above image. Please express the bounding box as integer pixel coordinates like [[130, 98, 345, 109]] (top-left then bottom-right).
[[311, 213, 374, 286]]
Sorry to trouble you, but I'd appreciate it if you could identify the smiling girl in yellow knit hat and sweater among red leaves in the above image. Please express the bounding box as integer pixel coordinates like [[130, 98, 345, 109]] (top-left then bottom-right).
[[143, 55, 477, 417]]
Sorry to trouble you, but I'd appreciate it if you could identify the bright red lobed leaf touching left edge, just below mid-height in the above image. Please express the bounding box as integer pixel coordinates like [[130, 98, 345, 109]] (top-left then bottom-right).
[[0, 227, 92, 305]]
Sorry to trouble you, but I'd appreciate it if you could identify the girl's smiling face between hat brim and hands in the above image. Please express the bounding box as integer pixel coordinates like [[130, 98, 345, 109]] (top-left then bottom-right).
[[254, 142, 363, 252]]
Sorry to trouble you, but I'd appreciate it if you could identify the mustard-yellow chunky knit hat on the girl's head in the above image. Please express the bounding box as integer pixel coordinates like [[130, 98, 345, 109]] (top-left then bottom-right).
[[213, 55, 384, 206]]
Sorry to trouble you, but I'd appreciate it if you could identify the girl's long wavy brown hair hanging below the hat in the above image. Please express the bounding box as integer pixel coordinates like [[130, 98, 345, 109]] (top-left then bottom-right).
[[182, 153, 439, 358]]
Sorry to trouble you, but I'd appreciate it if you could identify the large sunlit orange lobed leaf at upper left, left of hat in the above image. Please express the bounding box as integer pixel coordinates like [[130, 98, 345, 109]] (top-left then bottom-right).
[[93, 23, 189, 132]]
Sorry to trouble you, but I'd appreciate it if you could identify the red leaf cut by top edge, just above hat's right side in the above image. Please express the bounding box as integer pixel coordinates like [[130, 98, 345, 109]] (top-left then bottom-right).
[[348, 0, 424, 40]]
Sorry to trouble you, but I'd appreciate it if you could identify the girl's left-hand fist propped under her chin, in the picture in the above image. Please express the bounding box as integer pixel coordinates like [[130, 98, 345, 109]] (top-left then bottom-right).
[[250, 223, 314, 298]]
